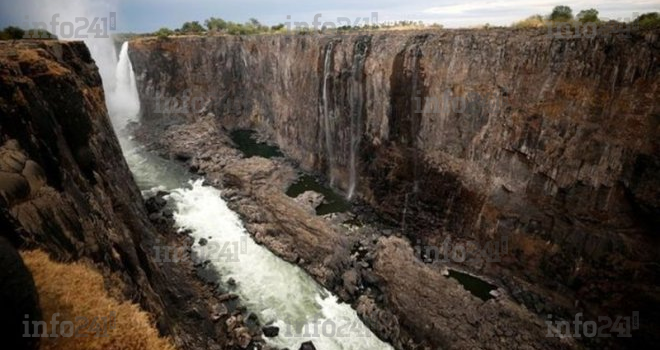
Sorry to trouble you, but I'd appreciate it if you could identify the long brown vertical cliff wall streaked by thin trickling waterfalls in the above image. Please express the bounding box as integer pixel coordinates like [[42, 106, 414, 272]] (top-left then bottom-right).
[[130, 30, 660, 348]]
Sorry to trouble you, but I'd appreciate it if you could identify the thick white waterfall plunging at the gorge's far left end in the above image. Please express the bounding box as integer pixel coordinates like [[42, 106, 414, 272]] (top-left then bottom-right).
[[107, 41, 140, 129]]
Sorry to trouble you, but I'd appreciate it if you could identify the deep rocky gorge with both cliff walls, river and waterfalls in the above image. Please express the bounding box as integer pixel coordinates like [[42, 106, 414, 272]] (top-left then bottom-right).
[[0, 11, 660, 350]]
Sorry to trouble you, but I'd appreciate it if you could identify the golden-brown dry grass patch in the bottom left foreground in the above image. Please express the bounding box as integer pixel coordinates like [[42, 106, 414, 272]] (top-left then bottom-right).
[[21, 251, 175, 350]]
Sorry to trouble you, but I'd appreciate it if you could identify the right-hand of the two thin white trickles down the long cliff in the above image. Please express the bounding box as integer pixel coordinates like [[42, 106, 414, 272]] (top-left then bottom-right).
[[347, 40, 368, 199]]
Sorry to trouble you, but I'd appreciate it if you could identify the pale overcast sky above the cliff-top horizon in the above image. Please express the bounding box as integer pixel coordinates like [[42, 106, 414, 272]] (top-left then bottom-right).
[[0, 0, 660, 32]]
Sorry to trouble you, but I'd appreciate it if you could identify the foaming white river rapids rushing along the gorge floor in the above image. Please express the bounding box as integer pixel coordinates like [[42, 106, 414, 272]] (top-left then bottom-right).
[[170, 180, 391, 350]]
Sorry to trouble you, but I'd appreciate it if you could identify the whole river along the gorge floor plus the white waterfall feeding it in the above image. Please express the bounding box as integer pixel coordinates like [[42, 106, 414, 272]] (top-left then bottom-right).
[[112, 43, 392, 350]]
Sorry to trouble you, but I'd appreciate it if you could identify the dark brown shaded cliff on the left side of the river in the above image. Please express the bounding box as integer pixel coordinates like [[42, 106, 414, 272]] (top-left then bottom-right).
[[0, 41, 240, 349]]
